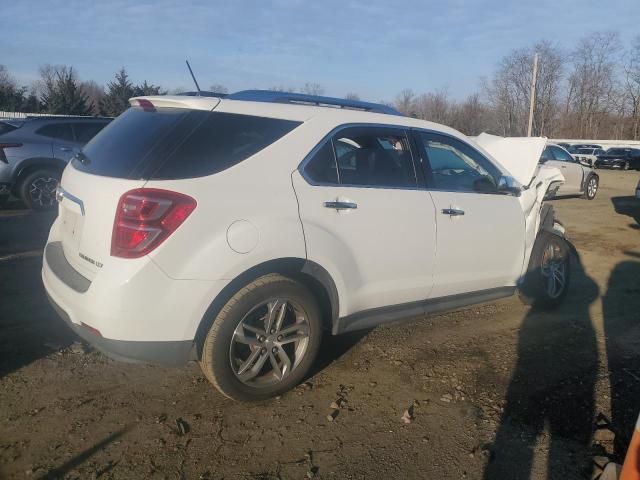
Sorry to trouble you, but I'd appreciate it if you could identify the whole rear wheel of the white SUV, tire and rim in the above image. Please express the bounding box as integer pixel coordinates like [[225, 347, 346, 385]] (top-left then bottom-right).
[[200, 274, 322, 401]]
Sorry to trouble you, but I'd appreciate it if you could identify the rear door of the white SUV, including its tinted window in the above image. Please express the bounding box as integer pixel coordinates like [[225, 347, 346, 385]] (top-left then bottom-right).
[[293, 126, 435, 316]]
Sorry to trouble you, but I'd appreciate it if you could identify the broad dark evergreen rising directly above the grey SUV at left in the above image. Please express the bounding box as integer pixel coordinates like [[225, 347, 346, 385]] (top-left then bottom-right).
[[42, 67, 91, 115]]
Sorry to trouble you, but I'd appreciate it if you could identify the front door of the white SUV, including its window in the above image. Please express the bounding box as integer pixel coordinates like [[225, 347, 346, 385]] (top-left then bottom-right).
[[415, 131, 525, 298]]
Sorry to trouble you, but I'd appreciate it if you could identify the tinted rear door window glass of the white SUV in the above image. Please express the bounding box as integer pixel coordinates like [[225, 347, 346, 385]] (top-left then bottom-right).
[[304, 127, 417, 188]]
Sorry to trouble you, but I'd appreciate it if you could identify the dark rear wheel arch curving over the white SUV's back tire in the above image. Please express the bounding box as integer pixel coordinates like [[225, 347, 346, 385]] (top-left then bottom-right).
[[194, 257, 339, 358]]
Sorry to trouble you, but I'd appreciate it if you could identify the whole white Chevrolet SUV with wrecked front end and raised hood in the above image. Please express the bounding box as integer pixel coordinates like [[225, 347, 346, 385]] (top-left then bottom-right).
[[42, 91, 569, 400]]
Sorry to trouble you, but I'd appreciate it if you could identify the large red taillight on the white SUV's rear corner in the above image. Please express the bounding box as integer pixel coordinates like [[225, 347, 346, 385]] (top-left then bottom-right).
[[111, 188, 197, 258]]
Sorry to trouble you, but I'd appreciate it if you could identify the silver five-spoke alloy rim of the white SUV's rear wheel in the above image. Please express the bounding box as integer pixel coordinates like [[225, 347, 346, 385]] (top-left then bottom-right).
[[229, 298, 310, 387]]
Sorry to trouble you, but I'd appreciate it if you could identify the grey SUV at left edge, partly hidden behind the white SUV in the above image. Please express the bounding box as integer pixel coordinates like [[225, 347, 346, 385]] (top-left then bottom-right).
[[0, 117, 111, 210]]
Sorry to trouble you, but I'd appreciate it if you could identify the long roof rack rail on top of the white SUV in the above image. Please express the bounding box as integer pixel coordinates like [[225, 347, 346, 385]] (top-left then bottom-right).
[[226, 90, 402, 115]]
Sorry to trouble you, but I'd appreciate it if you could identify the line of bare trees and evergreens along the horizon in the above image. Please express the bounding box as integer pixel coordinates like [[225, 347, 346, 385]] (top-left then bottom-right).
[[0, 32, 640, 140]]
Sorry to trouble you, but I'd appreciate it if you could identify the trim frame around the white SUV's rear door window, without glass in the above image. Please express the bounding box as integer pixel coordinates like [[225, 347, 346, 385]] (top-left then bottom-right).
[[297, 122, 422, 191]]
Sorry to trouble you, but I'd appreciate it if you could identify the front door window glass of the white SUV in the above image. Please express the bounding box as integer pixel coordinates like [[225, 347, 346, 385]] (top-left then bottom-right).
[[419, 133, 500, 193]]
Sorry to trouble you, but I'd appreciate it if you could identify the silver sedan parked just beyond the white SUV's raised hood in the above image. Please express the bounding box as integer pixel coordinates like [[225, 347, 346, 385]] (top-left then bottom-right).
[[540, 144, 600, 200]]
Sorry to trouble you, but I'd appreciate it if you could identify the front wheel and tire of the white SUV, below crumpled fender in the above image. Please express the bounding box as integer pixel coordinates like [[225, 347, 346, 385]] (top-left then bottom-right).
[[518, 230, 571, 310]]
